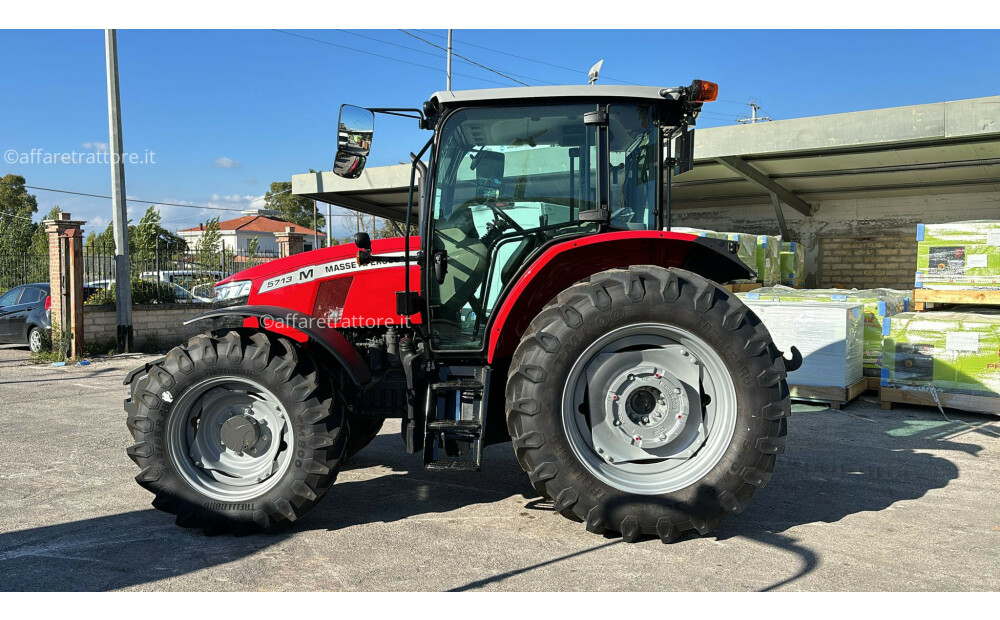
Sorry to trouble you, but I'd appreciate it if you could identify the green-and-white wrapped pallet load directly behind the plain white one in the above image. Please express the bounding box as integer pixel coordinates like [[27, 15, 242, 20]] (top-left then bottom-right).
[[739, 286, 911, 377]]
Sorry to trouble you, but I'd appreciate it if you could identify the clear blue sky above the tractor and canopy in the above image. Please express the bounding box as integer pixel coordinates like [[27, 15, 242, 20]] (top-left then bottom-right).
[[0, 30, 1000, 237]]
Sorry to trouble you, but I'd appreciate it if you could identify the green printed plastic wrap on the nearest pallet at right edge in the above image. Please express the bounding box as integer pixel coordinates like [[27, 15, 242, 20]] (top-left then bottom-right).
[[882, 309, 1000, 398]]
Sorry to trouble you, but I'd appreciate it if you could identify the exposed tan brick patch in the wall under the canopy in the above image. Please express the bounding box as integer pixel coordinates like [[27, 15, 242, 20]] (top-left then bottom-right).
[[817, 235, 917, 290]]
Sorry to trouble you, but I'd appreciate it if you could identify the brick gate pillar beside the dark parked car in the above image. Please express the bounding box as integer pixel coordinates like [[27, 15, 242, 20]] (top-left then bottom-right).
[[42, 213, 84, 358]]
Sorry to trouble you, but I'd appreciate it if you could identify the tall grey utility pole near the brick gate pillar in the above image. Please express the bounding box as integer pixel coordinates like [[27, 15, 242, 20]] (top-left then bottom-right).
[[104, 29, 132, 353]]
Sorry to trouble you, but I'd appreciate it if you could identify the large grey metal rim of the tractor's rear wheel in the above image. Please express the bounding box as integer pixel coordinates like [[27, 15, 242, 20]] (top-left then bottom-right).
[[562, 323, 736, 495]]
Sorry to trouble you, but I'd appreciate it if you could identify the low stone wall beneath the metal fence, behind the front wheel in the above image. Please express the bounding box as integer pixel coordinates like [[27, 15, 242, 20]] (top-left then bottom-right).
[[83, 304, 212, 352]]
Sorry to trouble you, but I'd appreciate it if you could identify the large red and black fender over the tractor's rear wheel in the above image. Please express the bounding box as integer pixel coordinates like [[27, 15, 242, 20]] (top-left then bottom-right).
[[486, 230, 757, 363]]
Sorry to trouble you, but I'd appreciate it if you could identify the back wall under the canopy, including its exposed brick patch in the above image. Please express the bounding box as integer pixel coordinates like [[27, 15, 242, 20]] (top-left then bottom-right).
[[673, 192, 1000, 289]]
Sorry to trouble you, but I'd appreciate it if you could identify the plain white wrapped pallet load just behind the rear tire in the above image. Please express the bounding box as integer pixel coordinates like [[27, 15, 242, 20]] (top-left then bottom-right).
[[744, 294, 864, 389]]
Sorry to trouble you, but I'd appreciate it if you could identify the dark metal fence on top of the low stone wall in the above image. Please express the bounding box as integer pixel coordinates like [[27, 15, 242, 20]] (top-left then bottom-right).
[[83, 243, 278, 303]]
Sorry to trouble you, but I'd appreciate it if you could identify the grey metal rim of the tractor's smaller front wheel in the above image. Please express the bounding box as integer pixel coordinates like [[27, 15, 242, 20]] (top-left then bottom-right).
[[167, 377, 295, 501]]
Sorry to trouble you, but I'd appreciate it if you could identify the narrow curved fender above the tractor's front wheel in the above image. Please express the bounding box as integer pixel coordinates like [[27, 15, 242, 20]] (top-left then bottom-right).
[[184, 306, 372, 387]]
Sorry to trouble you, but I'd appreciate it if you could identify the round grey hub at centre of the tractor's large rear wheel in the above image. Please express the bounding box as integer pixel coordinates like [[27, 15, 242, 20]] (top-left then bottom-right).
[[607, 366, 690, 448]]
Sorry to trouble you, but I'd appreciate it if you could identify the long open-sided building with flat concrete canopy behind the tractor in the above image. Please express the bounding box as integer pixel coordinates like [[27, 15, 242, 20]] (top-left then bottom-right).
[[292, 96, 1000, 289]]
